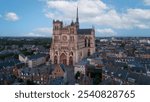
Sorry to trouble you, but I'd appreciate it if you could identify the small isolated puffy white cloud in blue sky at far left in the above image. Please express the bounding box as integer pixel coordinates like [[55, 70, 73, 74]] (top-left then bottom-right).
[[5, 12, 19, 21]]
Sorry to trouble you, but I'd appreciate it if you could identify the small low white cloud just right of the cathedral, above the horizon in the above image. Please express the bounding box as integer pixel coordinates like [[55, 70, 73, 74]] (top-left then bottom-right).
[[96, 28, 117, 37]]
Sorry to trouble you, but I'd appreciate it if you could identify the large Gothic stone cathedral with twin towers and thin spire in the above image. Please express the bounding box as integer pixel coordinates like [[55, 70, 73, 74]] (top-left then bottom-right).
[[50, 8, 95, 65]]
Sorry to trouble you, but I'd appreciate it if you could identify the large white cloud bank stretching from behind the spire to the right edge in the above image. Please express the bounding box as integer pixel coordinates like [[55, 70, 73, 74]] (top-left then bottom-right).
[[45, 0, 150, 29]]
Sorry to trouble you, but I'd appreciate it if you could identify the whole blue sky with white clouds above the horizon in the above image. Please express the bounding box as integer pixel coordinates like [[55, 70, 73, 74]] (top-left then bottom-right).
[[0, 0, 150, 37]]
